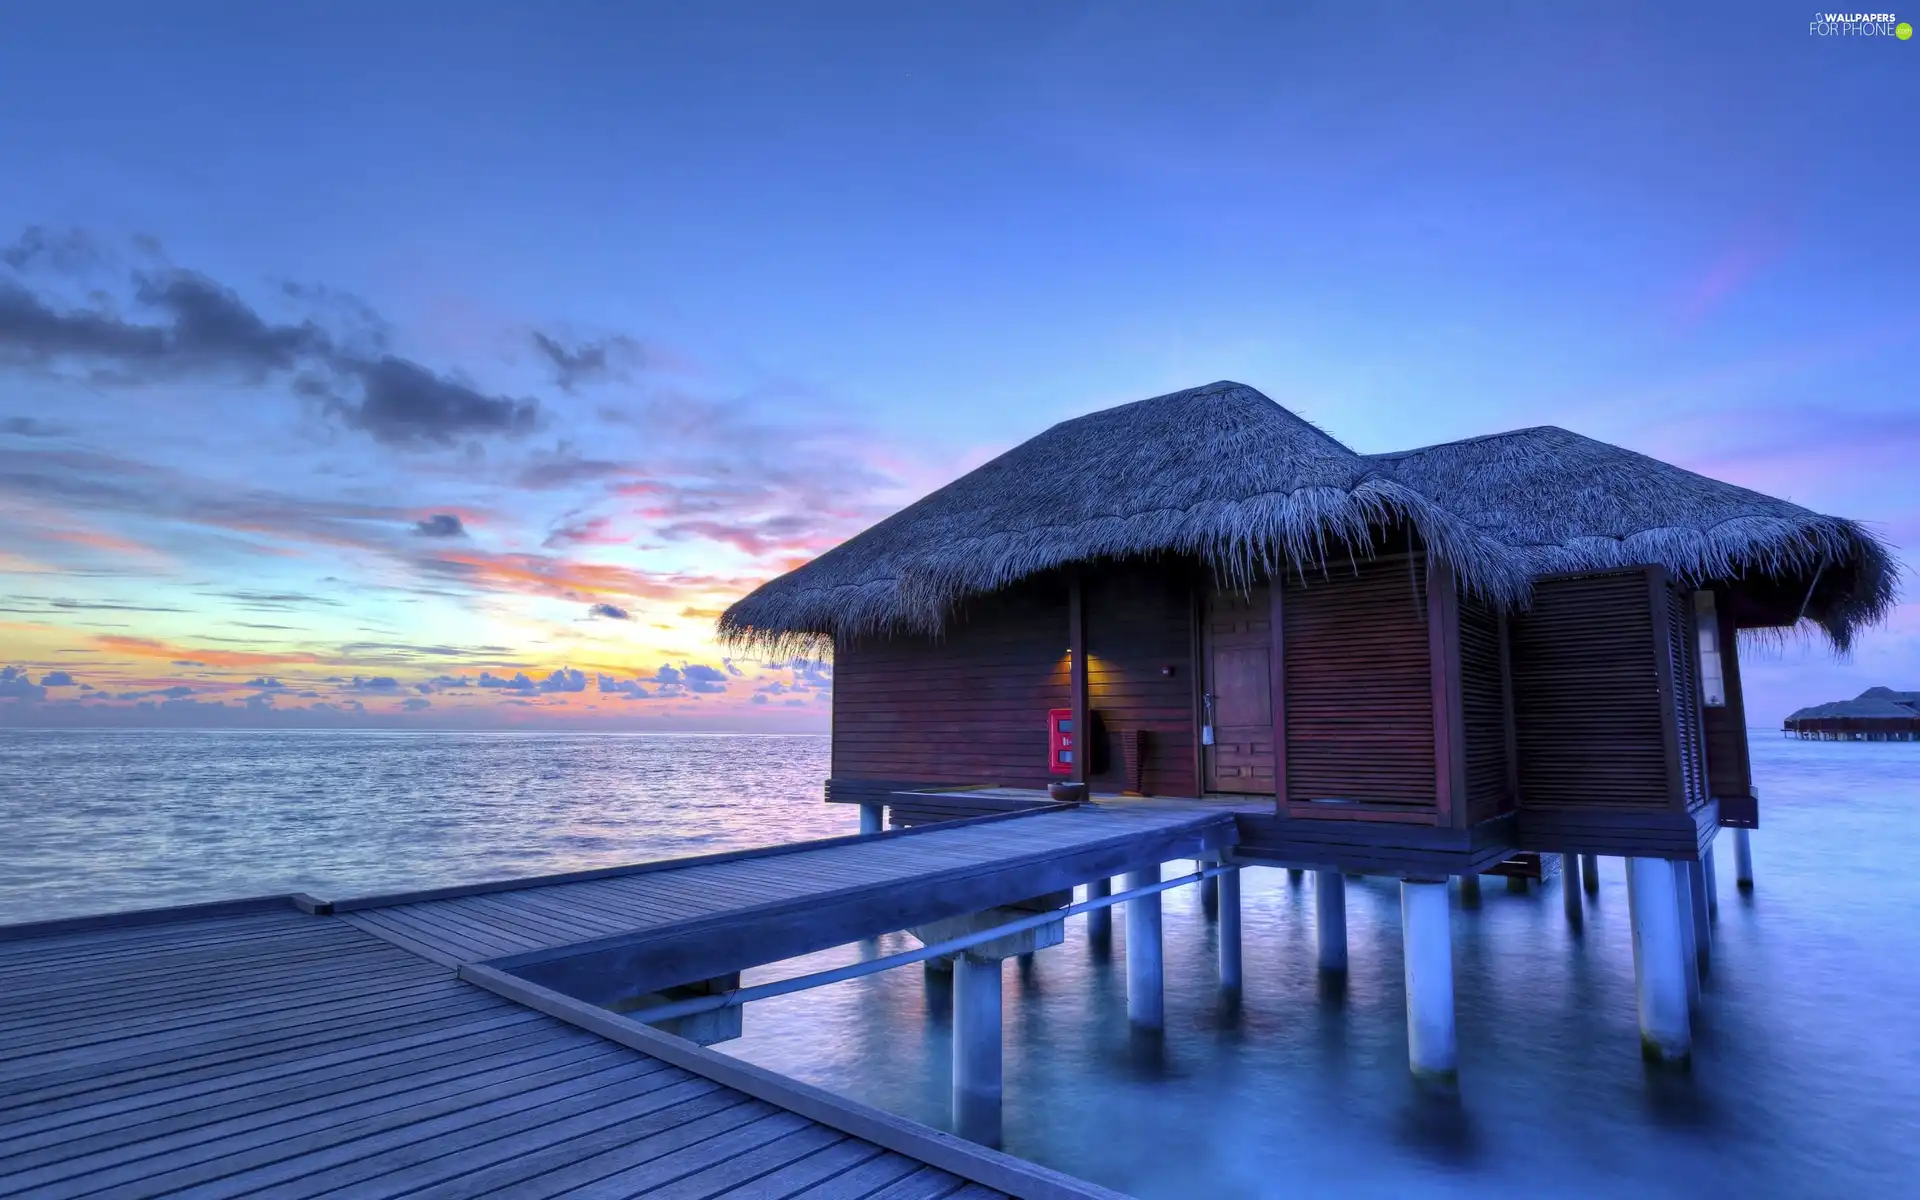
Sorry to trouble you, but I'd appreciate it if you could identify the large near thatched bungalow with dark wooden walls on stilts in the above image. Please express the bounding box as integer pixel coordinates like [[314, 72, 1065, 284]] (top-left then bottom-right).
[[720, 382, 1895, 1069]]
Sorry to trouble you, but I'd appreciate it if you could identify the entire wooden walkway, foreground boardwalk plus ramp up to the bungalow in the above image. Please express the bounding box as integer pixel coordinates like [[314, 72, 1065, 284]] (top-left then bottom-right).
[[0, 804, 1233, 1200]]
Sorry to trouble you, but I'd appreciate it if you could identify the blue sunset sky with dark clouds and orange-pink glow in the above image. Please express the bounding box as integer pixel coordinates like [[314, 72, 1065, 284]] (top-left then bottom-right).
[[0, 0, 1920, 730]]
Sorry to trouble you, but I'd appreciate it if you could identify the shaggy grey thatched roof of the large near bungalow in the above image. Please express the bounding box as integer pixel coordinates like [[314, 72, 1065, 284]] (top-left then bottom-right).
[[720, 382, 1895, 653]]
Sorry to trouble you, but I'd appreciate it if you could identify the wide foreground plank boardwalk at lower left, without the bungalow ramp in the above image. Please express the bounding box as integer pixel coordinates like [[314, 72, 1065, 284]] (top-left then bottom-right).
[[0, 897, 1029, 1200]]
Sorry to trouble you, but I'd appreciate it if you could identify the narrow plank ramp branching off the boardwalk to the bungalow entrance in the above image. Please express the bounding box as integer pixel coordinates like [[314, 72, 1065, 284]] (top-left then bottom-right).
[[334, 801, 1236, 1004]]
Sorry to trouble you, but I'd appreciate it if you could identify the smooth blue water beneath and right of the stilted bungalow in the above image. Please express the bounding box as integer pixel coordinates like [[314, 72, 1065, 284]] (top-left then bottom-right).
[[720, 739, 1920, 1198]]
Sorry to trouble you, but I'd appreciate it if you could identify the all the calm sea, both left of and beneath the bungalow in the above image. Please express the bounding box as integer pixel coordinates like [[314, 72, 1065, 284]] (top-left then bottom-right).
[[0, 732, 1920, 1200]]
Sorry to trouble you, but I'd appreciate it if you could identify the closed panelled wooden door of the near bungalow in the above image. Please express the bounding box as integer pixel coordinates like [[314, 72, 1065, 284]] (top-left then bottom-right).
[[1200, 586, 1273, 795]]
